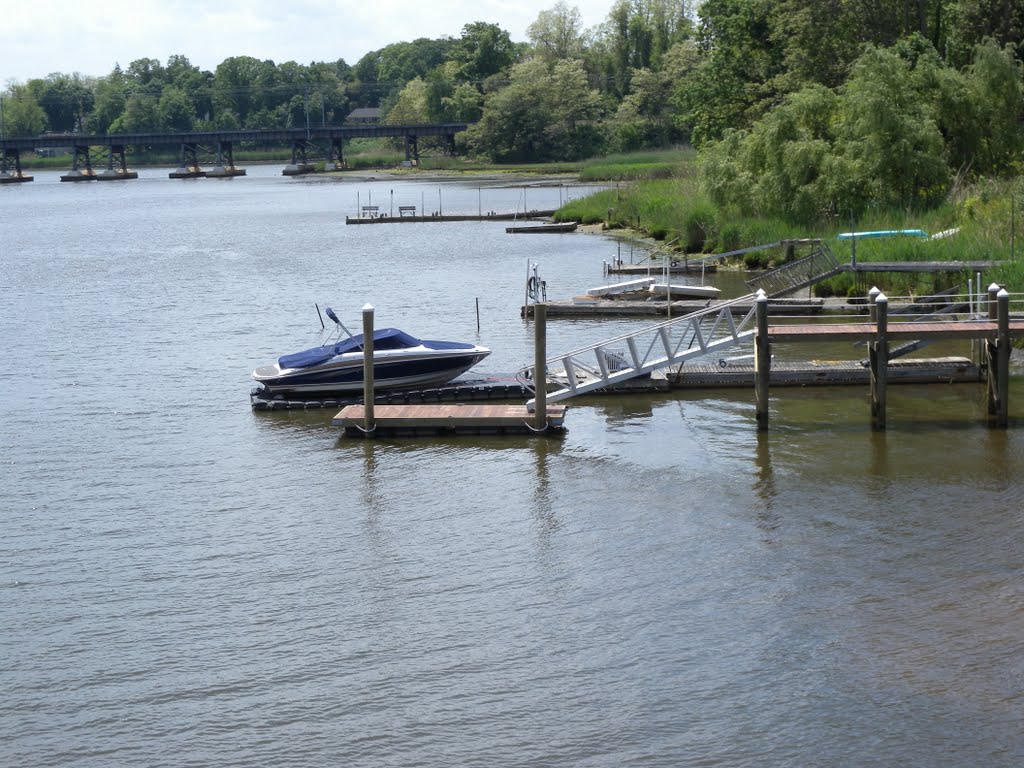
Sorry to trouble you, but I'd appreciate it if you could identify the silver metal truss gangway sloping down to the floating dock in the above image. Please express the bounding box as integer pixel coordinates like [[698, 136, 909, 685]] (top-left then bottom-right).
[[526, 294, 758, 411]]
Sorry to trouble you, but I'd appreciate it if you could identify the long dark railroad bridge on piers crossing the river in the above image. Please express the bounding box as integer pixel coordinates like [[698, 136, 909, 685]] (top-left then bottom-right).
[[0, 123, 469, 183]]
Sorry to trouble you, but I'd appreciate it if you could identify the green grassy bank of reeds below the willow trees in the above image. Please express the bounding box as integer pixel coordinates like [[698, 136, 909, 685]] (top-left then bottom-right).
[[556, 155, 1024, 296]]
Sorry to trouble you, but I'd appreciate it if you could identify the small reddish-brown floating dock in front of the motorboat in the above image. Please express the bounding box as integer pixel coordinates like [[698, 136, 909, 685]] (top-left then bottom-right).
[[331, 403, 566, 437]]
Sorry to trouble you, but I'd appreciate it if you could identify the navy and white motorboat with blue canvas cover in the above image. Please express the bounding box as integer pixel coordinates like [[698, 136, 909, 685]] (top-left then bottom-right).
[[252, 307, 490, 396]]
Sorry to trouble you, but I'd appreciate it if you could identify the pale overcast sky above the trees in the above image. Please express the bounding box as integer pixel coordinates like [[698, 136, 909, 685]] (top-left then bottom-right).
[[0, 0, 613, 86]]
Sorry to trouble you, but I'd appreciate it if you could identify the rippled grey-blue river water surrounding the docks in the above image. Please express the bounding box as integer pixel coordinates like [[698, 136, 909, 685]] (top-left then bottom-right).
[[0, 167, 1024, 768]]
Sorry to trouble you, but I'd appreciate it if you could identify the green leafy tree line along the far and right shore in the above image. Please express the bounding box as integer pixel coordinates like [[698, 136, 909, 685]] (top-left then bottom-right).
[[0, 0, 1024, 217]]
